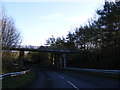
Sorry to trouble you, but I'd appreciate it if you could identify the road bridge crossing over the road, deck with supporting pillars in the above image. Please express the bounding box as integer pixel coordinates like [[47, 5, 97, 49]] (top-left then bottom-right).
[[4, 46, 81, 68]]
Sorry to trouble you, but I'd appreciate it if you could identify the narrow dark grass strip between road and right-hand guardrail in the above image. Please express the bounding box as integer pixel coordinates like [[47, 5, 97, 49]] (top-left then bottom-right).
[[61, 69, 120, 82]]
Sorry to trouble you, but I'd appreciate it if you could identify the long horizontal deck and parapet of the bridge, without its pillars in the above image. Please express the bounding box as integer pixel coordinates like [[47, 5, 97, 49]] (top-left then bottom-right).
[[10, 45, 81, 53]]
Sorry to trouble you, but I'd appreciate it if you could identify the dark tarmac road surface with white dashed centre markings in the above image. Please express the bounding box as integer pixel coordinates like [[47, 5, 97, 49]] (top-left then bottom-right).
[[26, 68, 120, 90]]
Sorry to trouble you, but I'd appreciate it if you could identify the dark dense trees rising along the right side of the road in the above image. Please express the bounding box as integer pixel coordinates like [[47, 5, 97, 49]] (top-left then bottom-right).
[[46, 2, 120, 69]]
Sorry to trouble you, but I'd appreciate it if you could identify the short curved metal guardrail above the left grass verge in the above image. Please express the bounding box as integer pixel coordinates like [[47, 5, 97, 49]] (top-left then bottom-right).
[[0, 69, 31, 79]]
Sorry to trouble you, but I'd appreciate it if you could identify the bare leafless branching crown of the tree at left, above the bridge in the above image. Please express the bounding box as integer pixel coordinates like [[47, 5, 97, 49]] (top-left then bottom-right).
[[1, 9, 21, 49]]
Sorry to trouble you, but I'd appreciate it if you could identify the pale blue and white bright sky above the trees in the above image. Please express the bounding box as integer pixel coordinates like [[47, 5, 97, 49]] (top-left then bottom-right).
[[2, 0, 111, 46]]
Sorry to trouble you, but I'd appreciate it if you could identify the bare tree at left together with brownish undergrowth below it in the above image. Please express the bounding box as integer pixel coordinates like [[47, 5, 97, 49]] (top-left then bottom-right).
[[0, 7, 21, 74]]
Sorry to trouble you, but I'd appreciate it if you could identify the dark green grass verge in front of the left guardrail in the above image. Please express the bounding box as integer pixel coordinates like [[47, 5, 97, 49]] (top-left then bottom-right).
[[2, 71, 36, 89]]
